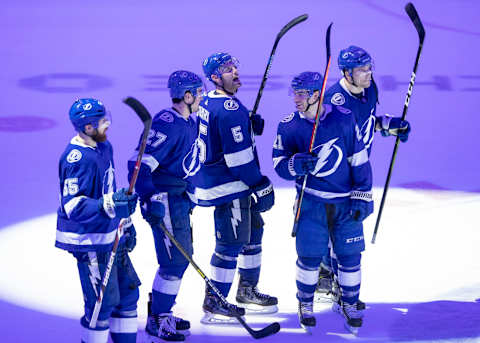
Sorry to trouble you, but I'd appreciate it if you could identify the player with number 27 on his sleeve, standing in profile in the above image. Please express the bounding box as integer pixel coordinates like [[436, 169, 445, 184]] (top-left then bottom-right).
[[128, 70, 204, 341]]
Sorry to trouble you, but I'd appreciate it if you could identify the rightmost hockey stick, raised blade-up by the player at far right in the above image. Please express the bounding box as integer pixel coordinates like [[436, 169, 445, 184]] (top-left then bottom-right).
[[372, 2, 425, 244]]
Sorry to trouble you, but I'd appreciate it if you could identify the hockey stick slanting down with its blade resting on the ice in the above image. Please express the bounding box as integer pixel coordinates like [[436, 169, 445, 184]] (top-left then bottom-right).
[[159, 223, 280, 339]]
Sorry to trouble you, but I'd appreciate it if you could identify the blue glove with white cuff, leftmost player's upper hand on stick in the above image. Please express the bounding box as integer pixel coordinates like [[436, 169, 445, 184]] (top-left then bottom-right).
[[98, 188, 138, 218]]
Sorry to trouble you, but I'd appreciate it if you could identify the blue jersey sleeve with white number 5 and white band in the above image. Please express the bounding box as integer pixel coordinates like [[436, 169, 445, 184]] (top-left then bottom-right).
[[218, 107, 262, 187]]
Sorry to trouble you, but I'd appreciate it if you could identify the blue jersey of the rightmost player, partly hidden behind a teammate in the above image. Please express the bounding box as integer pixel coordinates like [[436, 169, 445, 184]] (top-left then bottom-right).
[[323, 79, 378, 155]]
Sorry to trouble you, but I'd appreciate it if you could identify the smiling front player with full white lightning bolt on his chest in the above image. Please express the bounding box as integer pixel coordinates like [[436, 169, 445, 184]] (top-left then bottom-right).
[[273, 72, 373, 332]]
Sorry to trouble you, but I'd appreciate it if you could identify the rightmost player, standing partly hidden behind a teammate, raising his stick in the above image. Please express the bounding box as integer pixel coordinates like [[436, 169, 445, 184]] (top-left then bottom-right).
[[317, 45, 410, 309]]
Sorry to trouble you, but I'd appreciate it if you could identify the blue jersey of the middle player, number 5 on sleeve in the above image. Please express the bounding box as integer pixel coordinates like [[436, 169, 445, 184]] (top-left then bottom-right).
[[189, 91, 262, 206]]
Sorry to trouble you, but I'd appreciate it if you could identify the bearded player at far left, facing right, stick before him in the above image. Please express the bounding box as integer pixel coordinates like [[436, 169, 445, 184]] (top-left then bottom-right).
[[55, 98, 140, 343]]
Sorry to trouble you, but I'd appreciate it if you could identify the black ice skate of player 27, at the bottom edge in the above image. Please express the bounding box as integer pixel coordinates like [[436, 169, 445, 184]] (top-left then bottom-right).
[[145, 313, 186, 343]]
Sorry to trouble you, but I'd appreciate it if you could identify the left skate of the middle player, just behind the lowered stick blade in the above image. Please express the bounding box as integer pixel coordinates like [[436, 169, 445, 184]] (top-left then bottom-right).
[[200, 291, 245, 325]]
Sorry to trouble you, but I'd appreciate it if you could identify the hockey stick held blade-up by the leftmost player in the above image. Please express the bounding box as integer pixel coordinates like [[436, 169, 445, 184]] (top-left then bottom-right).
[[89, 97, 152, 329]]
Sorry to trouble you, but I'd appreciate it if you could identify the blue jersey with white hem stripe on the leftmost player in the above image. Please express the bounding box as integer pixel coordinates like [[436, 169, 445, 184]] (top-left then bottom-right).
[[55, 136, 131, 251]]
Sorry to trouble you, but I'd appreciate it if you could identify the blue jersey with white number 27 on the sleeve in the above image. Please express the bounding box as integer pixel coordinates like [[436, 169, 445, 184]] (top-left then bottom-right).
[[128, 108, 197, 199]]
